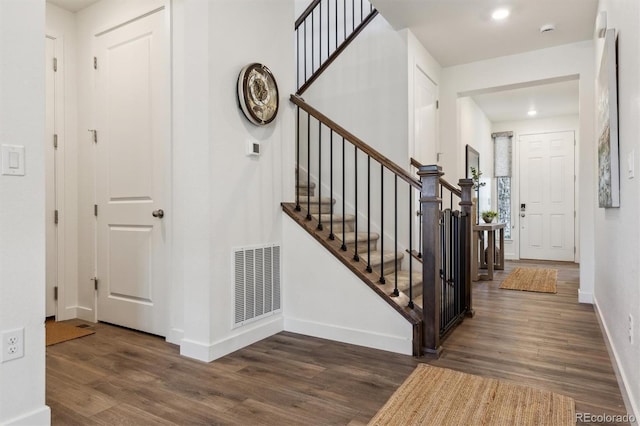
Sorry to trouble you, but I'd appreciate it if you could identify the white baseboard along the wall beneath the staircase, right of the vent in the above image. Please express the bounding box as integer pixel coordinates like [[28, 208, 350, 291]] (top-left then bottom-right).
[[284, 317, 413, 355]]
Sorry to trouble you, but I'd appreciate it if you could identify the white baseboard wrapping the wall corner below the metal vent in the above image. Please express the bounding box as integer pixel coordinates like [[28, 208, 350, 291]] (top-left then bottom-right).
[[180, 315, 284, 362]]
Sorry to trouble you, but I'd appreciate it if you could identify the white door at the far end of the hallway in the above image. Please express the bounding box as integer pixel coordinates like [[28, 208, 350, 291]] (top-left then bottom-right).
[[519, 132, 575, 261]]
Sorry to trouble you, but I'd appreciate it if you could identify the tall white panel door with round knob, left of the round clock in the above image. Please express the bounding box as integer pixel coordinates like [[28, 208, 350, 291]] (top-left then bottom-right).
[[95, 11, 169, 336]]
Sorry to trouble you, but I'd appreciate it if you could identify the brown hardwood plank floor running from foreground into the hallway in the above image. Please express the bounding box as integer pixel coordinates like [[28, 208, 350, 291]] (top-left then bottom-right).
[[47, 262, 625, 425]]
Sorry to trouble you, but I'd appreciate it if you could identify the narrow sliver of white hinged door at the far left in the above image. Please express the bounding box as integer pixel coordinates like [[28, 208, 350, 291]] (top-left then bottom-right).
[[44, 37, 58, 317]]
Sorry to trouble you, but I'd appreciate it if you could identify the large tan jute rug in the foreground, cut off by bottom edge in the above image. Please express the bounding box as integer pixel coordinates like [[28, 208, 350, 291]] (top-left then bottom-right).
[[369, 364, 575, 426]]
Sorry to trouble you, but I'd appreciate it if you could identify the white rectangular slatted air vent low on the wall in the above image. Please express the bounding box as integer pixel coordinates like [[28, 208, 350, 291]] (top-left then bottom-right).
[[233, 244, 280, 328]]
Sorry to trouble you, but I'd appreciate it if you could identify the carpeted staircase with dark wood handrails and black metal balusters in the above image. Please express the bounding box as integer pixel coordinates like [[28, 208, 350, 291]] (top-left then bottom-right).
[[282, 0, 472, 356]]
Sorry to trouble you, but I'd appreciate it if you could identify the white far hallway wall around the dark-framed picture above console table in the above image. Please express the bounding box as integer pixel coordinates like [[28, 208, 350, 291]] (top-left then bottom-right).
[[458, 97, 496, 212]]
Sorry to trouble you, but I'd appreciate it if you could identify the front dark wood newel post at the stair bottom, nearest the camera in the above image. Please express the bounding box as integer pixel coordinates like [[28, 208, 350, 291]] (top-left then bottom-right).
[[418, 165, 444, 356]]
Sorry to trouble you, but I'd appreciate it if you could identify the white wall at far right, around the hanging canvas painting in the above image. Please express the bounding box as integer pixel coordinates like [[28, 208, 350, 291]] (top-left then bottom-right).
[[592, 0, 640, 419]]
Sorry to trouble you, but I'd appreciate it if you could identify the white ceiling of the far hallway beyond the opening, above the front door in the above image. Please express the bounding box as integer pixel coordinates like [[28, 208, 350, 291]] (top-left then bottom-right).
[[471, 80, 579, 123]]
